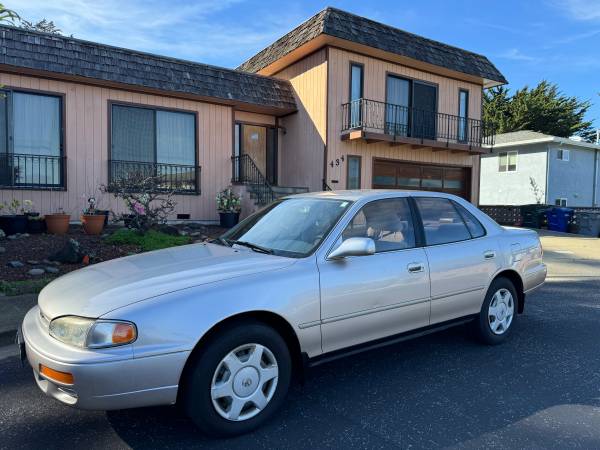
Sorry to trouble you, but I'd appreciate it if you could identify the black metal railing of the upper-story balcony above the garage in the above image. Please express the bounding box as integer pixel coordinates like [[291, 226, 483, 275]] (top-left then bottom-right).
[[342, 98, 494, 147]]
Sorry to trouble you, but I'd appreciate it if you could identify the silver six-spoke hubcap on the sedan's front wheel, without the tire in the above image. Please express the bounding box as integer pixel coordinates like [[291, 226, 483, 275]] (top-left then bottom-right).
[[211, 344, 279, 422]]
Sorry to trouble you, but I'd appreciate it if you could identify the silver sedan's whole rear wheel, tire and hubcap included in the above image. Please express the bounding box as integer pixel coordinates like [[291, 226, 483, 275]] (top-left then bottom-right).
[[473, 277, 518, 345]]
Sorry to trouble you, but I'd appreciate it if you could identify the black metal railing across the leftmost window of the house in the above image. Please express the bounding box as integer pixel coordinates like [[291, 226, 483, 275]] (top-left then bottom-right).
[[0, 153, 65, 189]]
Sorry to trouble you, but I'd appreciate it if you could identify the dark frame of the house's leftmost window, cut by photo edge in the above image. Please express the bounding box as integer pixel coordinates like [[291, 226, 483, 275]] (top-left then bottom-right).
[[0, 85, 67, 191]]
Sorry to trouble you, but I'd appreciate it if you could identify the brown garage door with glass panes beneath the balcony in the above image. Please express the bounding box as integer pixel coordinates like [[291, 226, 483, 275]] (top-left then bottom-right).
[[373, 159, 471, 200]]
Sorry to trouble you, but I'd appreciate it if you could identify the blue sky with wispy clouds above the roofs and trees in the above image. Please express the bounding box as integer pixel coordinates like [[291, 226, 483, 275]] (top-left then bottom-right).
[[10, 0, 600, 127]]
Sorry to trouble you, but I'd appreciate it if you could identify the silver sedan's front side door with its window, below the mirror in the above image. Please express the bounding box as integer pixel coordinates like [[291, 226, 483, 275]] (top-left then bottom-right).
[[319, 198, 430, 352]]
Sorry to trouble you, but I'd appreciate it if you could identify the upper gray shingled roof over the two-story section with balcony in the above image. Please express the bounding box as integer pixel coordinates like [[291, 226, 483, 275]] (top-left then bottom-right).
[[238, 7, 507, 83]]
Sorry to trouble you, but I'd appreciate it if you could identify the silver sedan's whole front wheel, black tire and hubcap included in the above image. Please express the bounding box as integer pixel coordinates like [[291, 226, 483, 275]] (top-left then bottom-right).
[[183, 321, 292, 437]]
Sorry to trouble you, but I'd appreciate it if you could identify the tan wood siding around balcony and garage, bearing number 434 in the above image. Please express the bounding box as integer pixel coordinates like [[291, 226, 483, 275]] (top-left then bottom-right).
[[326, 47, 482, 203]]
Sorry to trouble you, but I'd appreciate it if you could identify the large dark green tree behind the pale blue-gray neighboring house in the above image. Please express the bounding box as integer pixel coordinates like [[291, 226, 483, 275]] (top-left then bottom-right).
[[483, 80, 593, 140]]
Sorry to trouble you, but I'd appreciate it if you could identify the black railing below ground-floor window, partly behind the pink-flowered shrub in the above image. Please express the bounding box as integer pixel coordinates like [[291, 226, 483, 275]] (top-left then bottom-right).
[[108, 160, 200, 194]]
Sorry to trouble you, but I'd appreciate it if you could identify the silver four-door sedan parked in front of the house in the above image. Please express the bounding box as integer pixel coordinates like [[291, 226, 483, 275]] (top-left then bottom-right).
[[21, 191, 546, 435]]
